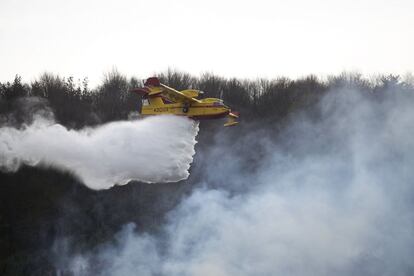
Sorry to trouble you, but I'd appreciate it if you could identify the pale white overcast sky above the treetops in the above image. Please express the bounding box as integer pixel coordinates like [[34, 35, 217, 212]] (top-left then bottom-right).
[[0, 0, 414, 85]]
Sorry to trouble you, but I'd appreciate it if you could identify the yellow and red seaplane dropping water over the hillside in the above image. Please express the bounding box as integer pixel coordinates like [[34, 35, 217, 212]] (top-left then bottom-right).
[[131, 77, 239, 126]]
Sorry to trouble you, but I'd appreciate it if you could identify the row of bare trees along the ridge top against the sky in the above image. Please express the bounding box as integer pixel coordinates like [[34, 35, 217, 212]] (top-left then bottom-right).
[[0, 70, 414, 128]]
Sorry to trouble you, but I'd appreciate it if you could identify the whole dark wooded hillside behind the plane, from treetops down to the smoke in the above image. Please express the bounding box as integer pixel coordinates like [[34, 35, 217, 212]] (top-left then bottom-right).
[[0, 70, 414, 275]]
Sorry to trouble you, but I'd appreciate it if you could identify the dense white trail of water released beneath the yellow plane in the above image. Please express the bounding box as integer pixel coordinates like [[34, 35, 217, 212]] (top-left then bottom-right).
[[0, 116, 198, 189]]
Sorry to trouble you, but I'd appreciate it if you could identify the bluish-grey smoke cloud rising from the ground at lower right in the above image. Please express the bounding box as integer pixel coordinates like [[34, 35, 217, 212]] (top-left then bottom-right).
[[59, 89, 414, 275]]
